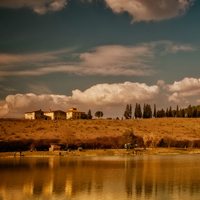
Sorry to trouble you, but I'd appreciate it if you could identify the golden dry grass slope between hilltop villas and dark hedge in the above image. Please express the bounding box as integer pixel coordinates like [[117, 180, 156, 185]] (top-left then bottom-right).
[[0, 118, 200, 142]]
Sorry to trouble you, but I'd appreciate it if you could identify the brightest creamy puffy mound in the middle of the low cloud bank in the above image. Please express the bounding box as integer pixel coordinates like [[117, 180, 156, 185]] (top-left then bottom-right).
[[72, 82, 159, 105]]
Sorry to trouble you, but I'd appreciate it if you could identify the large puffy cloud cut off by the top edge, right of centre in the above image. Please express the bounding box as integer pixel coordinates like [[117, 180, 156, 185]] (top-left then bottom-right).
[[105, 0, 194, 22]]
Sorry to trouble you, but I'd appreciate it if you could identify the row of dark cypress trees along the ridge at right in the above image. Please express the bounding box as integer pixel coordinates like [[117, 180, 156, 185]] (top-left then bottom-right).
[[123, 103, 200, 119]]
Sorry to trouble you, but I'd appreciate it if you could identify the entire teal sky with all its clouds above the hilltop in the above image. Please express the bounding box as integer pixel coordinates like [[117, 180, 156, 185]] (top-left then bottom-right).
[[0, 0, 200, 118]]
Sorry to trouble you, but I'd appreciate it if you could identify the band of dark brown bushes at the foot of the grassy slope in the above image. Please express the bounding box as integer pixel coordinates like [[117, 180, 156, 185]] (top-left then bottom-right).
[[0, 136, 200, 152]]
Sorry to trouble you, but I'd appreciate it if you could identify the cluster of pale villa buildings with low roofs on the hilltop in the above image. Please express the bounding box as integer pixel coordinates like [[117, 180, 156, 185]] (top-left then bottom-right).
[[25, 107, 85, 120]]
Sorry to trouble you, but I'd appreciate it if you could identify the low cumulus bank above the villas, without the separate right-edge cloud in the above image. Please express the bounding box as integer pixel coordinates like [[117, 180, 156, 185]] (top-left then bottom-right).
[[0, 82, 160, 117]]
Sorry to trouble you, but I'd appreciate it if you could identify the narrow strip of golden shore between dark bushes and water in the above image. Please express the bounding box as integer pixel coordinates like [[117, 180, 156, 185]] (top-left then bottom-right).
[[0, 148, 200, 158]]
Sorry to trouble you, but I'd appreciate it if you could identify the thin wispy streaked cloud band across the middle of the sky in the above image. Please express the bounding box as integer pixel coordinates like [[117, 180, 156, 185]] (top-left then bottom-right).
[[0, 41, 195, 76]]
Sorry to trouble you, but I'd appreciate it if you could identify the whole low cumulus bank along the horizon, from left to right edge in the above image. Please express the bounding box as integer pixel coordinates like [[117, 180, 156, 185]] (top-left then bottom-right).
[[0, 77, 200, 117]]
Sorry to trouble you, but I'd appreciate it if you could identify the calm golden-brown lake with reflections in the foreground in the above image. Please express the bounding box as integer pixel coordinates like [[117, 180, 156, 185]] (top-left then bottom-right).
[[0, 155, 200, 200]]
